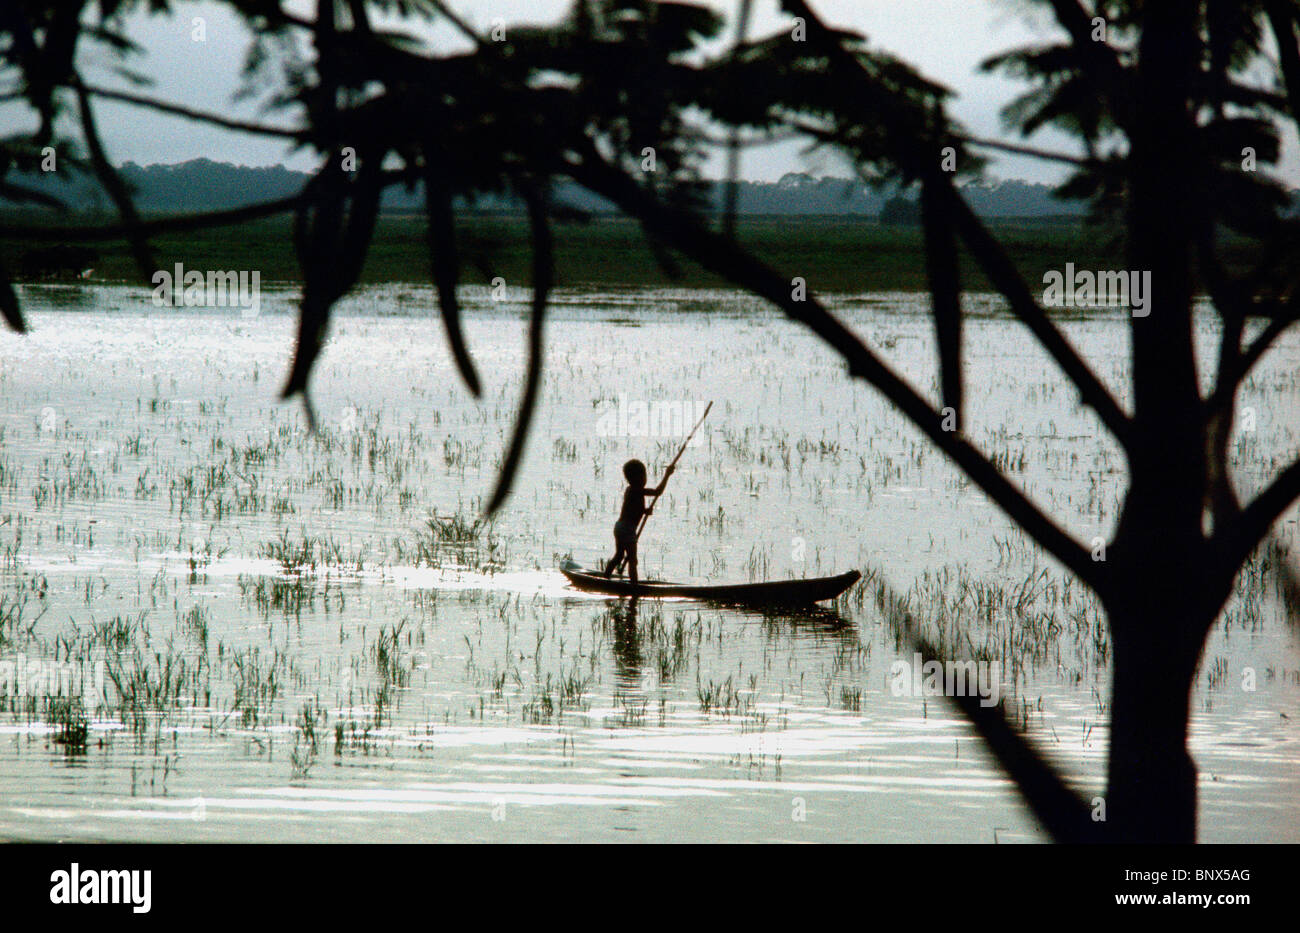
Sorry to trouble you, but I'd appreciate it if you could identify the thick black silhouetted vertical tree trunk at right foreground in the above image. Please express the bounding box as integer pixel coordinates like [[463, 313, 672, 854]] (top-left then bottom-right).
[[1105, 0, 1201, 842]]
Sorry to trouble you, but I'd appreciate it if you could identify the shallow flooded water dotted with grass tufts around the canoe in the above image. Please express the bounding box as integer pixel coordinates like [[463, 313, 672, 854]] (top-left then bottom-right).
[[0, 281, 1300, 842]]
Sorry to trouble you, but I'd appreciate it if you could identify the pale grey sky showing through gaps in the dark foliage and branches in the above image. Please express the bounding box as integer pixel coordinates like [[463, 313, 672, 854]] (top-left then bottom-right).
[[17, 0, 1300, 185]]
